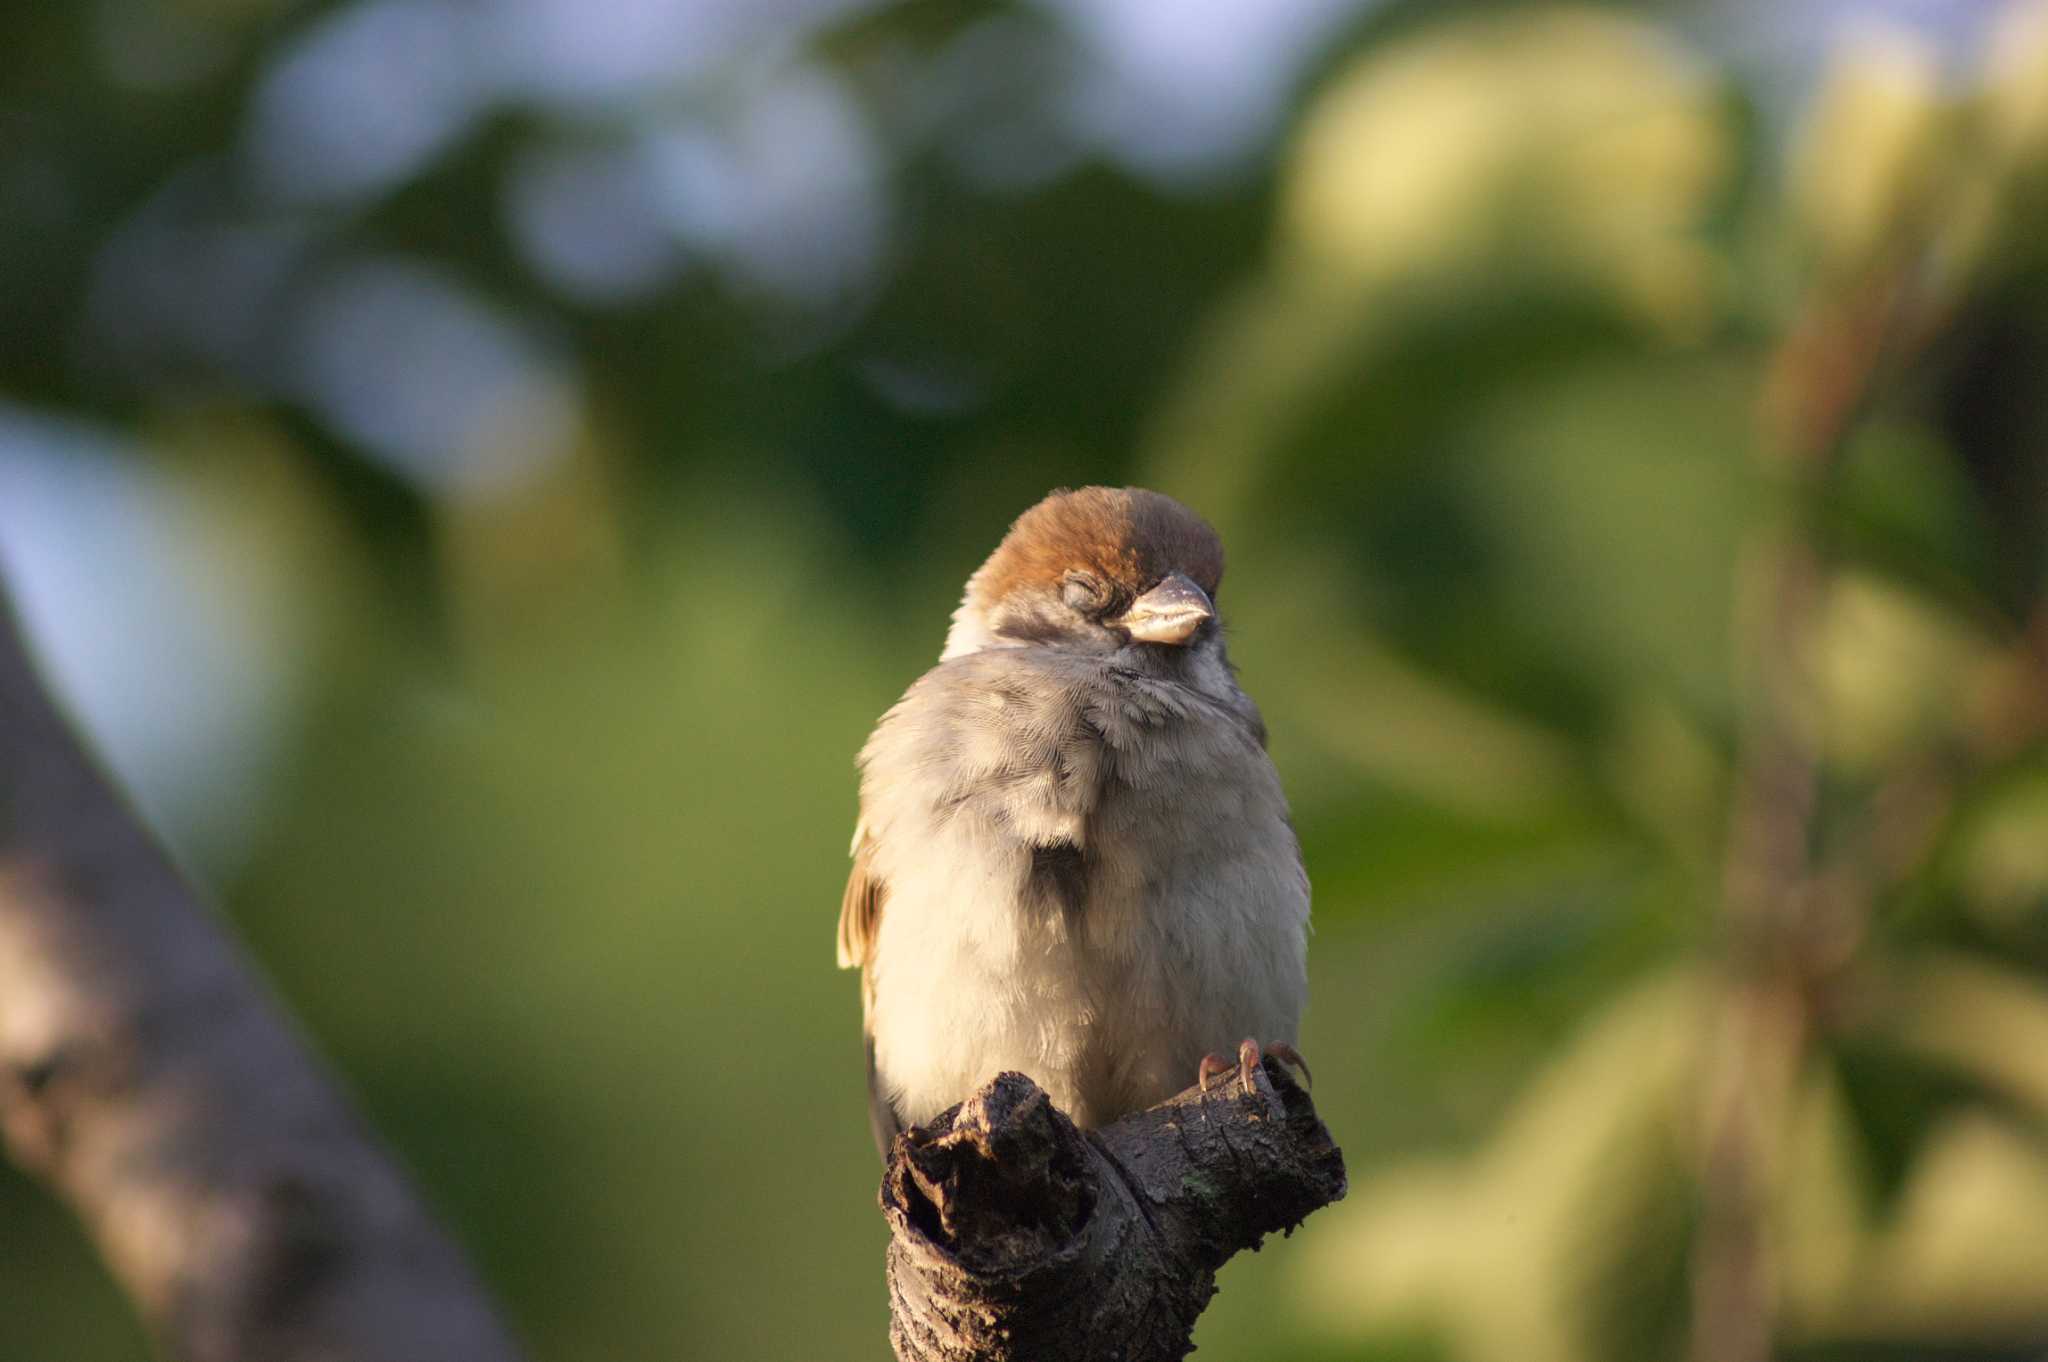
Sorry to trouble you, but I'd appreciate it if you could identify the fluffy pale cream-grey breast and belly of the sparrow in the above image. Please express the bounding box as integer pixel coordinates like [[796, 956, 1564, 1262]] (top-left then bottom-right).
[[862, 649, 1309, 1124]]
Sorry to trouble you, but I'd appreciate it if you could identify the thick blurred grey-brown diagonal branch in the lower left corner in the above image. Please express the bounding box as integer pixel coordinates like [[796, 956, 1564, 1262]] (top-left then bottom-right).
[[0, 592, 518, 1362]]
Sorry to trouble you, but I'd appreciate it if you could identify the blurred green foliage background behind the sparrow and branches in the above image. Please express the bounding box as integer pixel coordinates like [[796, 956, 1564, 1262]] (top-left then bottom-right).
[[0, 0, 2048, 1362]]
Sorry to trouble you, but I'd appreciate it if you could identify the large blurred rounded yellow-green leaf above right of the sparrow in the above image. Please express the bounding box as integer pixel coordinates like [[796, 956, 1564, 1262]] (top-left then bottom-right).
[[1282, 6, 1731, 332]]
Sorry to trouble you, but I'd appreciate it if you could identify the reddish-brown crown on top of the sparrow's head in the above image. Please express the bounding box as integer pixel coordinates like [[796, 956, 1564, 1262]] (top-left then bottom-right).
[[971, 487, 1223, 604]]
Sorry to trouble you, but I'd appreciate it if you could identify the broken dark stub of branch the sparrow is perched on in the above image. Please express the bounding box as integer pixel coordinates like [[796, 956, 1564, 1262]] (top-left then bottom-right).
[[883, 1059, 1346, 1362]]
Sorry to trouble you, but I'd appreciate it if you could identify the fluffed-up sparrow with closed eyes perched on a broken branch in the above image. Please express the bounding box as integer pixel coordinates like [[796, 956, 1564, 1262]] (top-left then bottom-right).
[[838, 487, 1309, 1159]]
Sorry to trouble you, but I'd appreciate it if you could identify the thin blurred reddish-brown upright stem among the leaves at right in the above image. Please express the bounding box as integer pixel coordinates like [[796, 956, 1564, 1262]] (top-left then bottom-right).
[[1692, 236, 1939, 1362]]
